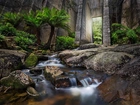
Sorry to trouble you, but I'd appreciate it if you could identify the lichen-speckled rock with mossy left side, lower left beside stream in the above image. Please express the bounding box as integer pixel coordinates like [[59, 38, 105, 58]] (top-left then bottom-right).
[[0, 70, 34, 89]]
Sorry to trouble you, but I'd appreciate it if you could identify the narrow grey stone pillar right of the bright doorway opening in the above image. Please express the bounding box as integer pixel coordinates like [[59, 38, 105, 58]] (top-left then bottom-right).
[[103, 0, 111, 46]]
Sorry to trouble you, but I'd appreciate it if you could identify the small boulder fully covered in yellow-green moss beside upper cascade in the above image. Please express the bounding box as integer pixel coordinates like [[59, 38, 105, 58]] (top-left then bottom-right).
[[25, 53, 38, 68]]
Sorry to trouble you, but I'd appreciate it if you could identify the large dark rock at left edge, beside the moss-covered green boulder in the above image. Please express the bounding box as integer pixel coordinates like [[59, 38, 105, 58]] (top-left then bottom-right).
[[0, 51, 22, 78]]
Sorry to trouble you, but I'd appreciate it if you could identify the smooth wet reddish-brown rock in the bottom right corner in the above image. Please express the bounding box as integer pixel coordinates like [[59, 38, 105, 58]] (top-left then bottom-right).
[[98, 76, 140, 105]]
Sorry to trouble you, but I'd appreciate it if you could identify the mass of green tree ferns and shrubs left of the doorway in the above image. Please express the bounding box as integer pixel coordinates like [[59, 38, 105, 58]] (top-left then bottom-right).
[[0, 8, 74, 50]]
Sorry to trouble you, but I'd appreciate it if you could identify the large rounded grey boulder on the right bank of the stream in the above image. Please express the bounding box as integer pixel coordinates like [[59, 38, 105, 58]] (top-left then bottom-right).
[[84, 51, 133, 74]]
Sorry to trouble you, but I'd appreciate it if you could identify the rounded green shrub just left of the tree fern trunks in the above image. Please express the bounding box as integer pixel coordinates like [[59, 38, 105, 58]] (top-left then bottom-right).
[[15, 31, 36, 50]]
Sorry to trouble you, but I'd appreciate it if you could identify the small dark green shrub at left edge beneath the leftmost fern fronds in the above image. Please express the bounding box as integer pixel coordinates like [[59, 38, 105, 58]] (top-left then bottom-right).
[[0, 23, 16, 36]]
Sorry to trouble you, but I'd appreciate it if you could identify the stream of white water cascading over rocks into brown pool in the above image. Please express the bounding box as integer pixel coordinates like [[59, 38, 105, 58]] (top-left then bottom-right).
[[0, 55, 106, 105]]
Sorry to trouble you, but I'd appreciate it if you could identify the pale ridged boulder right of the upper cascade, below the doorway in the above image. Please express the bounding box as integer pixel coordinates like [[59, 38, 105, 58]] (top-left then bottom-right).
[[58, 49, 97, 67]]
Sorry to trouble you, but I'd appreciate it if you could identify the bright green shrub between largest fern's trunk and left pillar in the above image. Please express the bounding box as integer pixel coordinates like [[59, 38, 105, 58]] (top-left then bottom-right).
[[56, 36, 74, 50]]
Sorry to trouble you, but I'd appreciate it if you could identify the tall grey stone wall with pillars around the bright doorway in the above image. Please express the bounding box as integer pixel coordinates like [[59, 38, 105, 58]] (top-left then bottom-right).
[[0, 0, 140, 45]]
